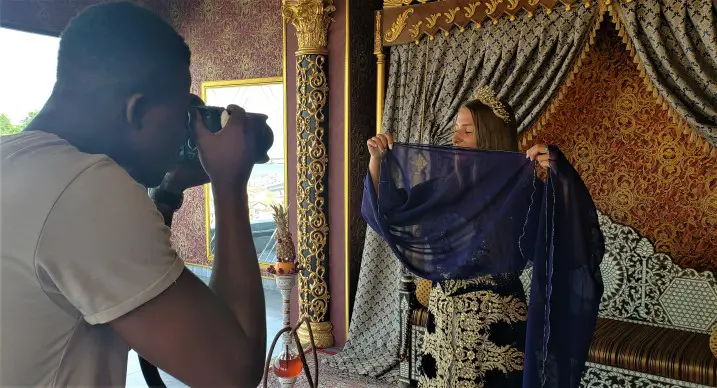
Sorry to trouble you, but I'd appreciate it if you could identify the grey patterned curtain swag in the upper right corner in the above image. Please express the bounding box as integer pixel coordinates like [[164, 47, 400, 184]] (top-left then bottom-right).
[[612, 0, 717, 146]]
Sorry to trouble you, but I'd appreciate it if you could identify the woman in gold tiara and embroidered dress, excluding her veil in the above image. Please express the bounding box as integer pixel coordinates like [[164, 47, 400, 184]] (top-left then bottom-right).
[[368, 94, 549, 387]]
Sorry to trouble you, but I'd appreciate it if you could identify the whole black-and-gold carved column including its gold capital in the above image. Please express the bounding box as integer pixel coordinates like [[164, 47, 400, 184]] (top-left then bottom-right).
[[282, 0, 336, 348]]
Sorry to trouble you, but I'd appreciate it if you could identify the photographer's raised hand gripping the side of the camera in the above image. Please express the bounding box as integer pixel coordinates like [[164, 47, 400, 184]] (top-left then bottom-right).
[[195, 105, 256, 185]]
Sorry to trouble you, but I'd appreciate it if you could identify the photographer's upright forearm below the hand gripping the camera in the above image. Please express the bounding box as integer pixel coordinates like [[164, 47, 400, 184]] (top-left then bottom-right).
[[209, 184, 266, 360]]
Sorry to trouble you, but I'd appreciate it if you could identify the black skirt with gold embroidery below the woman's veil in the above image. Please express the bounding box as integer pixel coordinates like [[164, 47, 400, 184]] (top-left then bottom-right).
[[419, 274, 528, 388]]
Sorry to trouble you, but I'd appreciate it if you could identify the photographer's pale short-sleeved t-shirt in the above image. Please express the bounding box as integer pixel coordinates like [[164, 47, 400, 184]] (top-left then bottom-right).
[[0, 132, 184, 387]]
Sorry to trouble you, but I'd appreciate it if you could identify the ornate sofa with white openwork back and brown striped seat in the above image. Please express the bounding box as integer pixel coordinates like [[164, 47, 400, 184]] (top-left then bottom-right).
[[399, 214, 717, 388]]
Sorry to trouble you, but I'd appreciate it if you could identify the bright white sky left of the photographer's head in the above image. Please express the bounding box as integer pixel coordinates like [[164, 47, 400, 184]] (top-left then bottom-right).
[[0, 28, 60, 124]]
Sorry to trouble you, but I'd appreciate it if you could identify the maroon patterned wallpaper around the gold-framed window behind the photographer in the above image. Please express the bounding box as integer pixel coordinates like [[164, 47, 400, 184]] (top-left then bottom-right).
[[169, 0, 282, 265]]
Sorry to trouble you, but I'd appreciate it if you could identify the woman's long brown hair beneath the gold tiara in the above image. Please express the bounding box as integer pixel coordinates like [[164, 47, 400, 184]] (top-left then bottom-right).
[[462, 100, 518, 151]]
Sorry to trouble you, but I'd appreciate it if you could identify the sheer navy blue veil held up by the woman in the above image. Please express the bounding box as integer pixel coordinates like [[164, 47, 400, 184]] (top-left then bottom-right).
[[362, 143, 604, 388]]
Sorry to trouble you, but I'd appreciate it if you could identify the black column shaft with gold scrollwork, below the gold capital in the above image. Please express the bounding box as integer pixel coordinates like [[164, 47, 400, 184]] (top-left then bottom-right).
[[296, 54, 333, 347]]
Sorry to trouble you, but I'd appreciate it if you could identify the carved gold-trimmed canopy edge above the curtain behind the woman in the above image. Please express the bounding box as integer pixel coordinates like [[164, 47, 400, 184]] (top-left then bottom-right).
[[381, 0, 592, 46]]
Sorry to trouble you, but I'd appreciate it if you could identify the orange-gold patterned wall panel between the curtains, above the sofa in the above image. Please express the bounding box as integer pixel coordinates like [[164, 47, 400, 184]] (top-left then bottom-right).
[[529, 26, 717, 270]]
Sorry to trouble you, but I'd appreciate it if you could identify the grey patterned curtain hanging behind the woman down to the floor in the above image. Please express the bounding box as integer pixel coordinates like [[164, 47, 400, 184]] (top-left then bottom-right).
[[327, 6, 602, 382]]
